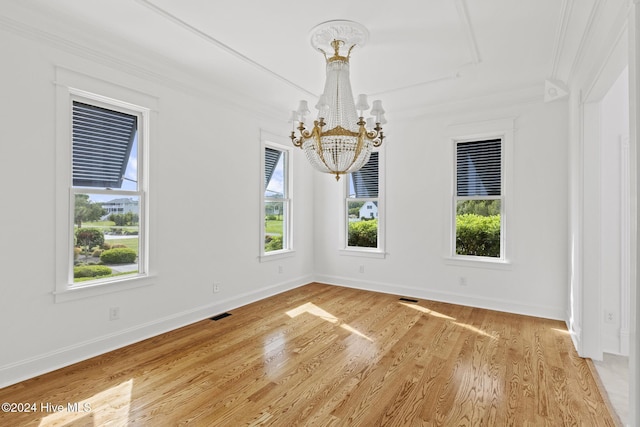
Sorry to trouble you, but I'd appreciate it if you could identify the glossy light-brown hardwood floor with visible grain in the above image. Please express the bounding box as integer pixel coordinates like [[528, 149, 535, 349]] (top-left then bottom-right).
[[0, 283, 615, 426]]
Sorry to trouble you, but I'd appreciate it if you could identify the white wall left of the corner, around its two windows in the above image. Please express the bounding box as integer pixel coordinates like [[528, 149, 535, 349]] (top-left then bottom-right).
[[0, 22, 313, 387]]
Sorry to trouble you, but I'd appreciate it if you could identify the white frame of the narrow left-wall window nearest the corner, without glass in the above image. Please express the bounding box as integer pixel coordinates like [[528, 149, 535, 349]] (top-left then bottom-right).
[[259, 132, 295, 262]]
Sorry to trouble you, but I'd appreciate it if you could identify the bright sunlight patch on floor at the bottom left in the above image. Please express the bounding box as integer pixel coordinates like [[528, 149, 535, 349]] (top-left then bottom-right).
[[40, 379, 133, 427]]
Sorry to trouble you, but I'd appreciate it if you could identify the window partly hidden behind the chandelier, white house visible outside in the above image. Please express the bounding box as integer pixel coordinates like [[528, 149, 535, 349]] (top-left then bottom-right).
[[345, 151, 381, 249]]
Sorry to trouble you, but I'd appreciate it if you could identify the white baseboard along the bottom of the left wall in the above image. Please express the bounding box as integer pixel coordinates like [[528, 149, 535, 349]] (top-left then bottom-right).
[[0, 276, 313, 388]]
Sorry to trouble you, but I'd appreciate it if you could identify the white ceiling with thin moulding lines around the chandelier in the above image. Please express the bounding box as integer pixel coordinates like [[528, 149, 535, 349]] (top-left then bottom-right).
[[5, 0, 600, 118]]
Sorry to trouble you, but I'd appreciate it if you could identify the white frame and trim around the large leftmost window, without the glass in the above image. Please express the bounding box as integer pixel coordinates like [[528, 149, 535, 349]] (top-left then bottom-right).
[[53, 68, 157, 302]]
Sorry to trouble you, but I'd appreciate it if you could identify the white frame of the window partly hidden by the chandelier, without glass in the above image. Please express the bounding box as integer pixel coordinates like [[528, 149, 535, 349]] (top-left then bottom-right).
[[338, 147, 387, 258]]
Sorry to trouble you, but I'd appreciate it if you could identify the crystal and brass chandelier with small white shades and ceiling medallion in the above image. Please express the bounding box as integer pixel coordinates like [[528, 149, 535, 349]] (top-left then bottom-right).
[[291, 20, 386, 180]]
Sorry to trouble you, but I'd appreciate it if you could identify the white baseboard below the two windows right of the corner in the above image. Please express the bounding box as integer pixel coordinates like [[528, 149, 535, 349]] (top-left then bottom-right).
[[315, 275, 566, 321]]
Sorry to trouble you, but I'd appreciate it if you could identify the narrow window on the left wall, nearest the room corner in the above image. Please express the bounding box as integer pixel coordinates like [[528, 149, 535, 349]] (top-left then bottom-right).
[[262, 143, 291, 255]]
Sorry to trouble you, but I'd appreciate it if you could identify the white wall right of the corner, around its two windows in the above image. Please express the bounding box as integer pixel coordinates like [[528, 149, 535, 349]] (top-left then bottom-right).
[[315, 101, 568, 319]]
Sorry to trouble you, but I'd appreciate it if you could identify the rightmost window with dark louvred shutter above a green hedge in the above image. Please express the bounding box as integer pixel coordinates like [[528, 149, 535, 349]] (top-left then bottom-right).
[[453, 139, 504, 259]]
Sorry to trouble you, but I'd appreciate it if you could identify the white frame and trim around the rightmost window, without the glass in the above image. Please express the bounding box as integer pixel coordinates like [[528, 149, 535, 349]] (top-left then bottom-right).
[[445, 118, 515, 268]]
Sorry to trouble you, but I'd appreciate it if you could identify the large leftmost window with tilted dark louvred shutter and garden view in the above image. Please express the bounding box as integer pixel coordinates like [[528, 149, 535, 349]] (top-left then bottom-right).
[[71, 98, 145, 286]]
